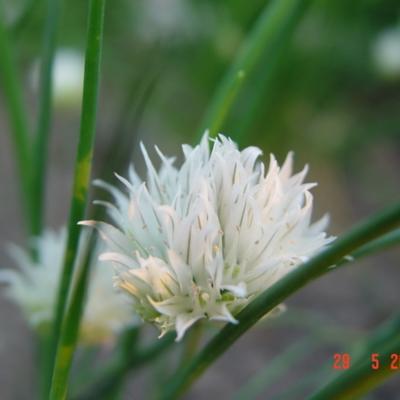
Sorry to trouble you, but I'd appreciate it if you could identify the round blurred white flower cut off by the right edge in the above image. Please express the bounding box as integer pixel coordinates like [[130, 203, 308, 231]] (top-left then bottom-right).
[[372, 27, 400, 79]]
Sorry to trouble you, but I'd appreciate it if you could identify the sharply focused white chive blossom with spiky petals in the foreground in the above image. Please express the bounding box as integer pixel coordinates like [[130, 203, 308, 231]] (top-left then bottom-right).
[[82, 135, 332, 340]]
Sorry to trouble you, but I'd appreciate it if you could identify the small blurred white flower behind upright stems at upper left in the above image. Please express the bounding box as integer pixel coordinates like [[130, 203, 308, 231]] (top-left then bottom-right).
[[31, 48, 85, 108]]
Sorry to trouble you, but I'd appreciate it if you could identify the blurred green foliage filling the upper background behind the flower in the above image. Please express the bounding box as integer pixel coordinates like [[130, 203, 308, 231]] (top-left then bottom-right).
[[3, 0, 400, 208]]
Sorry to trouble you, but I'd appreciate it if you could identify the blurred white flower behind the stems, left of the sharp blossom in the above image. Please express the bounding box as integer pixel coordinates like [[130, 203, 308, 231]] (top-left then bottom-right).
[[0, 229, 135, 344]]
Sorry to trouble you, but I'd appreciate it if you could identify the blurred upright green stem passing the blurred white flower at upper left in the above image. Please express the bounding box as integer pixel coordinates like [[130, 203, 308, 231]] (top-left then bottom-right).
[[32, 0, 61, 236]]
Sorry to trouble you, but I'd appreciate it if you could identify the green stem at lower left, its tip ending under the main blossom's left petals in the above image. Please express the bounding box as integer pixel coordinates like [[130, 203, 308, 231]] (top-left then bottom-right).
[[49, 234, 96, 400]]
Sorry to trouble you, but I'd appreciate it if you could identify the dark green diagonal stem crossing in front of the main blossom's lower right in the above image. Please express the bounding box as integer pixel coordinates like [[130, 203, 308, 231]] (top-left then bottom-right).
[[161, 204, 400, 400]]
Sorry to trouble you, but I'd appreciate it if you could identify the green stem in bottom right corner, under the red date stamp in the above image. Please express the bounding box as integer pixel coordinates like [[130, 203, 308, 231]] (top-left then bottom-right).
[[310, 316, 400, 400]]
